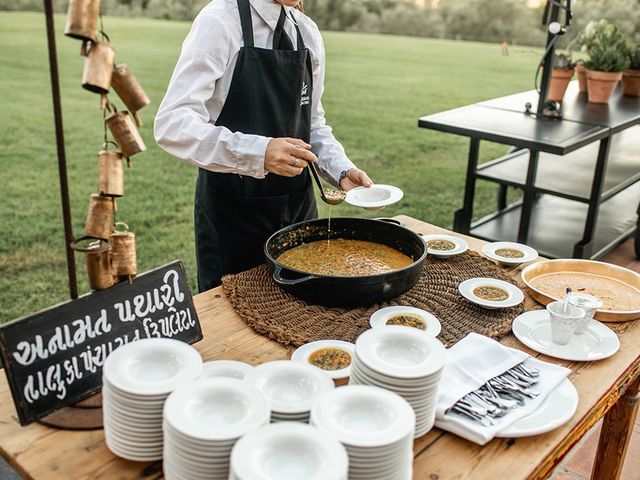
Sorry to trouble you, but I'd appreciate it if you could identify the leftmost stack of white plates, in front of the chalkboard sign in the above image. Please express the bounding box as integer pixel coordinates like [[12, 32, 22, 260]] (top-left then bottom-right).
[[102, 338, 202, 461]]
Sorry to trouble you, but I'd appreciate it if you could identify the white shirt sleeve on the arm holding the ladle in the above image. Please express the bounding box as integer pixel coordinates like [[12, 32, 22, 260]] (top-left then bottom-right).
[[154, 15, 271, 178]]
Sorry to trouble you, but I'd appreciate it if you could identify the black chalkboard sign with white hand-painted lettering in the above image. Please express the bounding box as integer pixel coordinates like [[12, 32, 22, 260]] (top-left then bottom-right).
[[0, 261, 202, 425]]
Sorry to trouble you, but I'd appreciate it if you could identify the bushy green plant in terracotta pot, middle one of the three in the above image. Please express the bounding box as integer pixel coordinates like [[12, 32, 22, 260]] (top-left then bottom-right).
[[584, 20, 629, 103]]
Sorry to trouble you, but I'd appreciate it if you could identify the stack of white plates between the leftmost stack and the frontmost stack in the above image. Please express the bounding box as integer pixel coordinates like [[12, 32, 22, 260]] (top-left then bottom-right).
[[163, 377, 271, 480]]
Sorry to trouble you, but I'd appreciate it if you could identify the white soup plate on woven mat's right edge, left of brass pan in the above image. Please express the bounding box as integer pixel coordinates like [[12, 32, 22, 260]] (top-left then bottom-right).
[[458, 278, 524, 310]]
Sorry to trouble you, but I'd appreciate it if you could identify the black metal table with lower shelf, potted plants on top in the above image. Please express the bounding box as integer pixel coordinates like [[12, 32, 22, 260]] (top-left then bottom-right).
[[418, 82, 640, 258]]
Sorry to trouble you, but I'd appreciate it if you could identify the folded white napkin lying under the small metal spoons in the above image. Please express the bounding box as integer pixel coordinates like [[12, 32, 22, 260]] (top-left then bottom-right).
[[435, 333, 571, 445]]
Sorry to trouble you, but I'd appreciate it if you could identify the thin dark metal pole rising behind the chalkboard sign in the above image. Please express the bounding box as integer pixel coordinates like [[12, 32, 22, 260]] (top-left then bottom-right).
[[44, 0, 78, 298]]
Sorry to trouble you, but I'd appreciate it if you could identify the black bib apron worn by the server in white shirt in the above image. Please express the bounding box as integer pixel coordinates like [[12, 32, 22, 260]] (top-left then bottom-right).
[[194, 0, 318, 292]]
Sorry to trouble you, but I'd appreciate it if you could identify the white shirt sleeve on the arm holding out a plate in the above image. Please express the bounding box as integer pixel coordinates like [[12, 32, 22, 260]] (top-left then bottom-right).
[[310, 27, 355, 186]]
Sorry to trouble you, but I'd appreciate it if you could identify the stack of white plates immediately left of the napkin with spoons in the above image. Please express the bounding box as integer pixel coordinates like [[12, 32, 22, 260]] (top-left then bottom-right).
[[349, 326, 446, 437]]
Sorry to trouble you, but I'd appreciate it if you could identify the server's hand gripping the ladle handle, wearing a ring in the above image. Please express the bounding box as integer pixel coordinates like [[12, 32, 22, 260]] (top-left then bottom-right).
[[264, 137, 318, 177]]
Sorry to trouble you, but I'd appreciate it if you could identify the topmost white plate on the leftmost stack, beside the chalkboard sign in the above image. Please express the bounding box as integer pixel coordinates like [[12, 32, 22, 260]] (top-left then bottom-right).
[[102, 338, 202, 395]]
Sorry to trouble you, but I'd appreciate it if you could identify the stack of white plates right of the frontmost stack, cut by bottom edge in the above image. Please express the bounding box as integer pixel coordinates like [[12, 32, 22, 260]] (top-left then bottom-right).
[[312, 384, 416, 480]]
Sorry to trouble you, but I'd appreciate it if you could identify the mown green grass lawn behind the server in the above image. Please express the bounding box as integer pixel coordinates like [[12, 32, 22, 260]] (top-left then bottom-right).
[[0, 12, 540, 322]]
